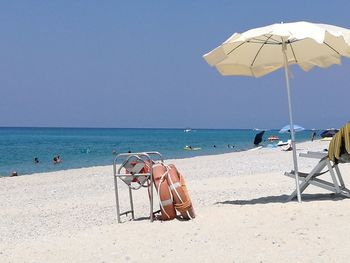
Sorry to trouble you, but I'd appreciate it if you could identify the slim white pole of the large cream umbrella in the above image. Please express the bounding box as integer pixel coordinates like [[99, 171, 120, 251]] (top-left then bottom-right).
[[282, 41, 301, 203]]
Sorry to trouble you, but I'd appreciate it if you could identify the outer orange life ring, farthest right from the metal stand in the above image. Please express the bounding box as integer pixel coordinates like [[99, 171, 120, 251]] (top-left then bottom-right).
[[167, 164, 195, 219]]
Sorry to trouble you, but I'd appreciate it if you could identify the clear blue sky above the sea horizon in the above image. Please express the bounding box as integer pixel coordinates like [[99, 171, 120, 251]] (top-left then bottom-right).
[[0, 0, 350, 128]]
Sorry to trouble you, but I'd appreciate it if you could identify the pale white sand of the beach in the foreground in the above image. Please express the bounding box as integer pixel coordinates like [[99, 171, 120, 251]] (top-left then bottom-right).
[[0, 141, 350, 262]]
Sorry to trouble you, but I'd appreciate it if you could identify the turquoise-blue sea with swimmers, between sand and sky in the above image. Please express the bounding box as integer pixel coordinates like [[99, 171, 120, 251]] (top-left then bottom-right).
[[0, 128, 312, 176]]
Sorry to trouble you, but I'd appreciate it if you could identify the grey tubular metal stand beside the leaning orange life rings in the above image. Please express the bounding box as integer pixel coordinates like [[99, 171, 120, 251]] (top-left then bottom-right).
[[113, 152, 164, 223]]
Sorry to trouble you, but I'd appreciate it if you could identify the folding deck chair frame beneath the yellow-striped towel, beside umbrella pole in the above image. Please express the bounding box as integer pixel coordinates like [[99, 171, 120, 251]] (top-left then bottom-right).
[[285, 152, 350, 201]]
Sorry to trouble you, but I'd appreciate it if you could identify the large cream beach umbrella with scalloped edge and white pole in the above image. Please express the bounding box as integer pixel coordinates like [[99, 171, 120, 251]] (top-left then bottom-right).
[[203, 22, 350, 202]]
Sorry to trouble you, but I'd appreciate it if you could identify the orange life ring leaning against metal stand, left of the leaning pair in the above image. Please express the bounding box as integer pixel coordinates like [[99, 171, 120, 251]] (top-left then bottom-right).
[[152, 164, 176, 220]]
